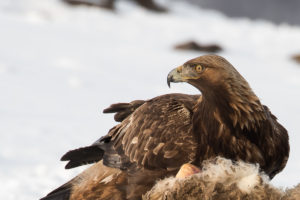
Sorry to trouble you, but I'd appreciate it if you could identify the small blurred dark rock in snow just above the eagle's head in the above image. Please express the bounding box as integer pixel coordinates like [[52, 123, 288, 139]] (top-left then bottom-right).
[[174, 41, 222, 53]]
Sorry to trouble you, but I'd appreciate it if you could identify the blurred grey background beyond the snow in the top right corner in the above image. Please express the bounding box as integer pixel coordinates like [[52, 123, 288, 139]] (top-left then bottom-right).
[[184, 0, 300, 25]]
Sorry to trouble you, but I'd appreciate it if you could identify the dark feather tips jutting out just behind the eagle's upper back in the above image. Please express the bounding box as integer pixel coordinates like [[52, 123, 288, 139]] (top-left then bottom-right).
[[103, 100, 145, 122]]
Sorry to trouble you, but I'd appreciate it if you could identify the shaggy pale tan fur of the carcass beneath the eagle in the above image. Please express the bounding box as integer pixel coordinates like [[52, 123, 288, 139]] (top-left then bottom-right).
[[143, 157, 300, 200]]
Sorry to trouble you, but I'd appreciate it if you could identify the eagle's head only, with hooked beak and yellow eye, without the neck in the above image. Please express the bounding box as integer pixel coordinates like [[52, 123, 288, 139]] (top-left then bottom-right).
[[167, 55, 251, 94]]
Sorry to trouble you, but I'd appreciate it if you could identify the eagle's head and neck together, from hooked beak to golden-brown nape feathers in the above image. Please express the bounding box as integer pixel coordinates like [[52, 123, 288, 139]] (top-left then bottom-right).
[[167, 55, 265, 130]]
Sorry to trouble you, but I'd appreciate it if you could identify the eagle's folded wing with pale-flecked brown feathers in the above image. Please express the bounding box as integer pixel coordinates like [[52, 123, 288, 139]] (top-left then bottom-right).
[[102, 94, 199, 169]]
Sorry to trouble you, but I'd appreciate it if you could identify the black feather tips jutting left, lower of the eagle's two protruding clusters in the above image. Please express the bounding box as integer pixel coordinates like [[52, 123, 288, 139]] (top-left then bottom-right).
[[60, 146, 104, 169]]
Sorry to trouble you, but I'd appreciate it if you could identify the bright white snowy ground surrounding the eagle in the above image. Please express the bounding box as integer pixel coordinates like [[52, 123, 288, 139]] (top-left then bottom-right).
[[0, 0, 300, 200]]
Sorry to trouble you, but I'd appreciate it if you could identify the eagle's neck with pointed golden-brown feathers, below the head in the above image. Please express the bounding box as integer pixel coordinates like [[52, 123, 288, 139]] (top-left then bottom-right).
[[196, 81, 266, 131]]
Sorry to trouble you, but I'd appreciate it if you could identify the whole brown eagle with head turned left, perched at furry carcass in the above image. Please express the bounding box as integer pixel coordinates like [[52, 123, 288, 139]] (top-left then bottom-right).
[[43, 55, 289, 200]]
